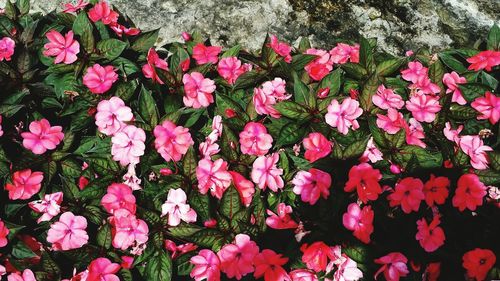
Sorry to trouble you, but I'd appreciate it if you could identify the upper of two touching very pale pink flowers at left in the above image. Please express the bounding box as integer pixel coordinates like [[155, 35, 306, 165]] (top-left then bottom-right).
[[95, 97, 134, 136]]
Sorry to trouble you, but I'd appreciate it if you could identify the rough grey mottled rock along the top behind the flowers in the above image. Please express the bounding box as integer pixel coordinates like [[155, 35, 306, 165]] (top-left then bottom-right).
[[0, 0, 500, 54]]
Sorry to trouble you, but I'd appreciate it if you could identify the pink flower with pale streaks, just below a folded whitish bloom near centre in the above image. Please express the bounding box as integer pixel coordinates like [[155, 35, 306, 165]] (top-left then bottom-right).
[[196, 158, 232, 199]]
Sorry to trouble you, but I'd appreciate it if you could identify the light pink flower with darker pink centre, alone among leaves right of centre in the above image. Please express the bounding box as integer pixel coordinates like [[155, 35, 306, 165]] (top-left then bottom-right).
[[325, 98, 363, 135]]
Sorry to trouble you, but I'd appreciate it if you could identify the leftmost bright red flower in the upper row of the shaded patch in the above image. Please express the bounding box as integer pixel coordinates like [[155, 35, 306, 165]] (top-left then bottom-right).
[[344, 163, 382, 204]]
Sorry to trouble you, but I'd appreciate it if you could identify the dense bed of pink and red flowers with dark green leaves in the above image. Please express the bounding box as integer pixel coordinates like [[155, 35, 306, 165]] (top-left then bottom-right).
[[0, 0, 500, 281]]
